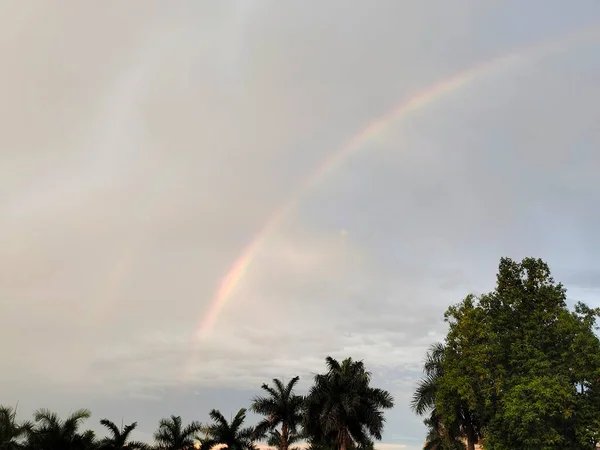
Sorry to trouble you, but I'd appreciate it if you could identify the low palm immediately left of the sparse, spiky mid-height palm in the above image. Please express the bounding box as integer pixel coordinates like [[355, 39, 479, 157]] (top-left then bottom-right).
[[201, 408, 256, 450]]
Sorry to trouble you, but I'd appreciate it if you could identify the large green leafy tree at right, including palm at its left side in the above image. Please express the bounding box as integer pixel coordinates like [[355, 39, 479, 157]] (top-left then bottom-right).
[[412, 258, 600, 450]]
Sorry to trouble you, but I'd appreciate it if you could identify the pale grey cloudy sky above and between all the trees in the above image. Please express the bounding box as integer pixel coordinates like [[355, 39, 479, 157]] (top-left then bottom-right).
[[0, 0, 600, 450]]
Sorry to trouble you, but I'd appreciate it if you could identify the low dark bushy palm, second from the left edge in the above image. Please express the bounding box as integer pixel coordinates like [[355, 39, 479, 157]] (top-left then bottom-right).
[[29, 409, 95, 450]]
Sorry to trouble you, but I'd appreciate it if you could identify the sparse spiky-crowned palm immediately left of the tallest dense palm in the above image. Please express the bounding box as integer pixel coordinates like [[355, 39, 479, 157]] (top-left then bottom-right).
[[250, 377, 304, 450]]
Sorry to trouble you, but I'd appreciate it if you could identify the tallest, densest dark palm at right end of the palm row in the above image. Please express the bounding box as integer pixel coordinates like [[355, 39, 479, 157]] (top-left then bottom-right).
[[304, 356, 394, 450]]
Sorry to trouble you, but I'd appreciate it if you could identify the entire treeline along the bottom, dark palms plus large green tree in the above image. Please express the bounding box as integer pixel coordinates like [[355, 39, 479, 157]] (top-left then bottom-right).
[[0, 258, 600, 450]]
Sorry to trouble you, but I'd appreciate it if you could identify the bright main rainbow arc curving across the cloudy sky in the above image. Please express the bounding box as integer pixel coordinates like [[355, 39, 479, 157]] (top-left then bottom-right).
[[179, 24, 598, 380]]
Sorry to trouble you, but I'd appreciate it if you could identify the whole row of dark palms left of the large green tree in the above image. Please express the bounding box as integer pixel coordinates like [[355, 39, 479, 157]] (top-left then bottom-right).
[[0, 357, 394, 450]]
